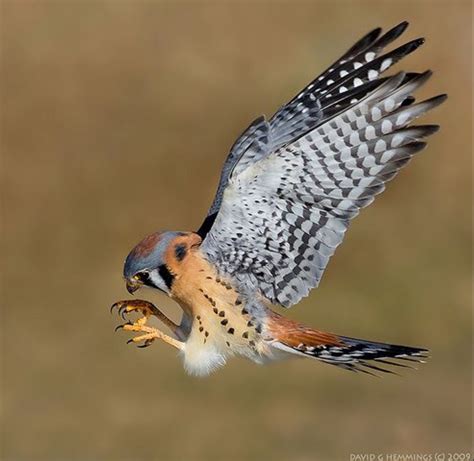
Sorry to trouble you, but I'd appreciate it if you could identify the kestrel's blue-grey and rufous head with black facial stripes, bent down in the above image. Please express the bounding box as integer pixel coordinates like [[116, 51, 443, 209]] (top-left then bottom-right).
[[123, 231, 200, 294]]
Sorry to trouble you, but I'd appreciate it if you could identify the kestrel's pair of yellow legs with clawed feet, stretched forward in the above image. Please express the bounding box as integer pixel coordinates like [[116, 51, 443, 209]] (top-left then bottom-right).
[[110, 299, 183, 349]]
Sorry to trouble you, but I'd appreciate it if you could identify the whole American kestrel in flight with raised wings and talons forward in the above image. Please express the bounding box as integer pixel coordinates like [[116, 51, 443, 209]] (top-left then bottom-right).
[[113, 22, 446, 375]]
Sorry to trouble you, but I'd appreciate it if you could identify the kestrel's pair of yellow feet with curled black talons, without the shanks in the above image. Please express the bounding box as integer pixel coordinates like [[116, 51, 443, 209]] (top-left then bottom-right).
[[110, 299, 162, 347]]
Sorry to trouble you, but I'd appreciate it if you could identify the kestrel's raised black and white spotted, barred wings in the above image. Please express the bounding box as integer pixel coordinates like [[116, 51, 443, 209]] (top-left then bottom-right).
[[198, 23, 445, 307]]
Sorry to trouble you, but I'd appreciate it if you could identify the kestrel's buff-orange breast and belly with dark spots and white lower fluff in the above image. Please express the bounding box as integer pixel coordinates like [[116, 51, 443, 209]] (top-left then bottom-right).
[[171, 250, 266, 375]]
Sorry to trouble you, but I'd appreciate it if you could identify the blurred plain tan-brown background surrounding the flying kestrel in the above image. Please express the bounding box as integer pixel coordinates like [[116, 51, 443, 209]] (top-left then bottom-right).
[[1, 0, 472, 461]]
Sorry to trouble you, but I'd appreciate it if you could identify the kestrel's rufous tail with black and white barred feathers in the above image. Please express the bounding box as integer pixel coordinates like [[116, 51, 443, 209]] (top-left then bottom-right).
[[270, 315, 428, 374]]
